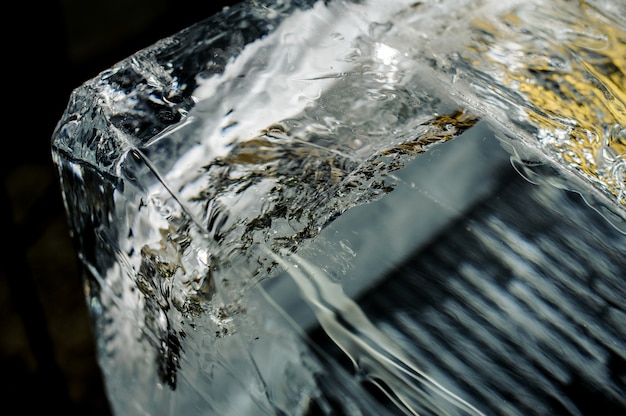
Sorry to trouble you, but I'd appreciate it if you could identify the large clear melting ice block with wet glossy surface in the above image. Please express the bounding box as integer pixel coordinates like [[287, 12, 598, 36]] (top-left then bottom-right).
[[52, 0, 626, 415]]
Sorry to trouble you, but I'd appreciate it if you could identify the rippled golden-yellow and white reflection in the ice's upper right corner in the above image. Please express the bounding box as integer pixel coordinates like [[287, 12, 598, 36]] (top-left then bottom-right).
[[464, 1, 626, 205]]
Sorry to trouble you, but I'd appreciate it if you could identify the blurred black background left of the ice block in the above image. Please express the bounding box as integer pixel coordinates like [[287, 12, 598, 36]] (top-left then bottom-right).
[[0, 0, 234, 415]]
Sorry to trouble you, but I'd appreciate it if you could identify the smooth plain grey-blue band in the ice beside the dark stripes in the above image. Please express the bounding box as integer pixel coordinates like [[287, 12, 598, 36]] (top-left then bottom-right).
[[263, 122, 512, 330]]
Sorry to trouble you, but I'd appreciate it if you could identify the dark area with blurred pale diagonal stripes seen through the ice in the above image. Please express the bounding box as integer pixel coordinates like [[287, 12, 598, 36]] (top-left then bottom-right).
[[318, 171, 626, 416]]
